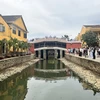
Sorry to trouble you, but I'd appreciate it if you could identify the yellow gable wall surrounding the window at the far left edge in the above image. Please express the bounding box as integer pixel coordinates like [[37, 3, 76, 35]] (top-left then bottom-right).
[[0, 16, 11, 40]]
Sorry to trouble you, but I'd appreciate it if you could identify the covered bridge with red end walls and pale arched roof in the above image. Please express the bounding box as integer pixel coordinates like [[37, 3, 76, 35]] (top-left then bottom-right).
[[29, 37, 81, 59]]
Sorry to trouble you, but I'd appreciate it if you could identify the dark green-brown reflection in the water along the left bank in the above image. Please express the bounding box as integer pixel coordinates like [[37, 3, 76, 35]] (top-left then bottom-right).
[[0, 67, 34, 100]]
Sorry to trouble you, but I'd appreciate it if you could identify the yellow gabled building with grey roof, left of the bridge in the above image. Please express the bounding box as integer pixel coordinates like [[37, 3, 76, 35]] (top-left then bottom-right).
[[0, 15, 28, 42]]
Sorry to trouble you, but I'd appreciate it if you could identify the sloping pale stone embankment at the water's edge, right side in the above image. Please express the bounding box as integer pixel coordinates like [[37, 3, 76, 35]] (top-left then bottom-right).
[[61, 58, 100, 91]]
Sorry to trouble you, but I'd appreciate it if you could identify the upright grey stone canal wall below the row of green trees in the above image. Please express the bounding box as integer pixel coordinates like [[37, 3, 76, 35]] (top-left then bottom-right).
[[0, 54, 34, 70]]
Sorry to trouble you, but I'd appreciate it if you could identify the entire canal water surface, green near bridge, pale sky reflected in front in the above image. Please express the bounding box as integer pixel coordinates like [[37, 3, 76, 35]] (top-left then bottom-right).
[[0, 59, 100, 100]]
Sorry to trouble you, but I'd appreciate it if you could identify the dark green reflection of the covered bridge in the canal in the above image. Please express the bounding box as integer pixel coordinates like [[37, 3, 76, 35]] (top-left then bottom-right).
[[34, 59, 72, 78]]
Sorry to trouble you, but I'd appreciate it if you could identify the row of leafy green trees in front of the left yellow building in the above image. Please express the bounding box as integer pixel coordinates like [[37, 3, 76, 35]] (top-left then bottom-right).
[[0, 37, 29, 55]]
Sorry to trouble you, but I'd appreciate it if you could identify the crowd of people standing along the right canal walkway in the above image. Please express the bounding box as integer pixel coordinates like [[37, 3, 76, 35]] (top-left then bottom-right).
[[67, 47, 100, 59]]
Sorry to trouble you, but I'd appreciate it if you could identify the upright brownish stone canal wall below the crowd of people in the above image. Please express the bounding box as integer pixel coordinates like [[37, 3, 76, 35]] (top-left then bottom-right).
[[65, 54, 100, 74]]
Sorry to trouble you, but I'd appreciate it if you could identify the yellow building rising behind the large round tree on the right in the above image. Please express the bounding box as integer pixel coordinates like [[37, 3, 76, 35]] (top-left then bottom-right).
[[76, 25, 100, 46]]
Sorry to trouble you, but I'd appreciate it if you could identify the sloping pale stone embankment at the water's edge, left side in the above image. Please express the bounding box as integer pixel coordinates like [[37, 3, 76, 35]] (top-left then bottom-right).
[[0, 59, 39, 81]]
